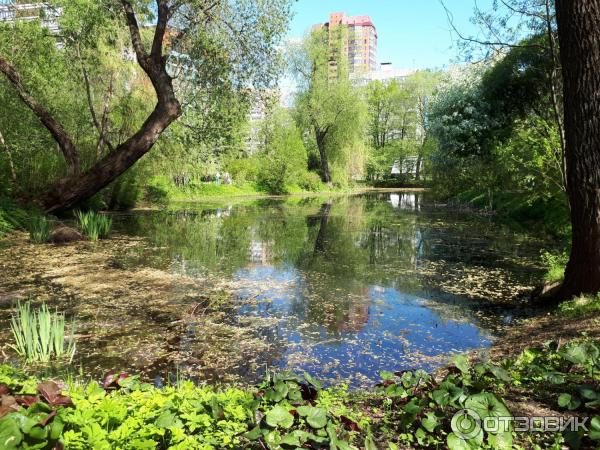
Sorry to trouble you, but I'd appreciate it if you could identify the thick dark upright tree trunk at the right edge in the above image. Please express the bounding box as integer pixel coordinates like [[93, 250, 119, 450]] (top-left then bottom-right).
[[556, 0, 600, 298]]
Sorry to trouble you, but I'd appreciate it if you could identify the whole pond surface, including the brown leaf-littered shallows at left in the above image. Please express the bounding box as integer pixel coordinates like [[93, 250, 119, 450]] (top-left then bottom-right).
[[0, 192, 544, 387]]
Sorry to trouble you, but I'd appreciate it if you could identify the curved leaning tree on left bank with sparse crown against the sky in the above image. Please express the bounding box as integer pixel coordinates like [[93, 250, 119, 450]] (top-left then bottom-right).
[[0, 0, 290, 212]]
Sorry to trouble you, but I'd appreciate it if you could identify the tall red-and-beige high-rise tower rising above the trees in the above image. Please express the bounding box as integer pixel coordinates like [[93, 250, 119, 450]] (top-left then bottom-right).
[[313, 13, 377, 76]]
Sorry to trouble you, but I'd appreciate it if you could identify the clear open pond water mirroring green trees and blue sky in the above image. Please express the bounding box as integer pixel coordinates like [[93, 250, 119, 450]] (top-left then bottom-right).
[[110, 193, 538, 386]]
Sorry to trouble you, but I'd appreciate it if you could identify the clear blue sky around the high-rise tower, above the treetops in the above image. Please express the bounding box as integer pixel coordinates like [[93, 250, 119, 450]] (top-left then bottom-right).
[[289, 0, 489, 69]]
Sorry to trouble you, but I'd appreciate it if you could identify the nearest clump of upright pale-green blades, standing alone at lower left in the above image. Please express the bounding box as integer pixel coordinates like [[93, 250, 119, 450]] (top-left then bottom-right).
[[11, 302, 75, 363]]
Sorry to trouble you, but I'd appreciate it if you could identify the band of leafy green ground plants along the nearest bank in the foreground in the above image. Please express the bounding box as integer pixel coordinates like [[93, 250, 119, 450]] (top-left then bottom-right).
[[0, 337, 600, 450]]
